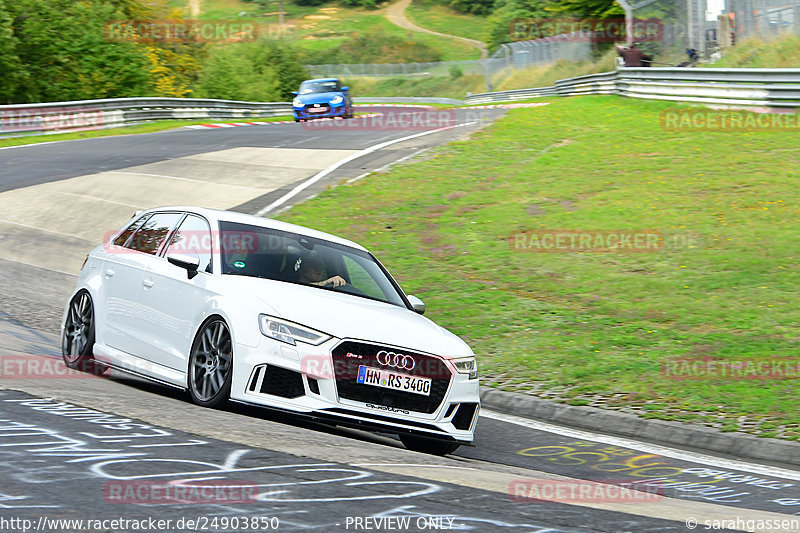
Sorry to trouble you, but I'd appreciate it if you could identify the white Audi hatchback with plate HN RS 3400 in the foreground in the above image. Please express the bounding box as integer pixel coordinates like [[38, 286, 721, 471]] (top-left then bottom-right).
[[62, 207, 480, 454]]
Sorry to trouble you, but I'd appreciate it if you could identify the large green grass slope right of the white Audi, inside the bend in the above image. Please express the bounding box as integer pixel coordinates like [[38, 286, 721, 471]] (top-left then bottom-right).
[[281, 96, 800, 439]]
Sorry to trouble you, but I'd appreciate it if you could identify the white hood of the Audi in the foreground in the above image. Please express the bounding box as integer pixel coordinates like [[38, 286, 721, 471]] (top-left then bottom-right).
[[225, 276, 473, 357]]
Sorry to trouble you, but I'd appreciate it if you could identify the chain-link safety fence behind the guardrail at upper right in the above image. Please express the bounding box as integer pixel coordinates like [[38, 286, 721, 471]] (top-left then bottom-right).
[[308, 0, 800, 85]]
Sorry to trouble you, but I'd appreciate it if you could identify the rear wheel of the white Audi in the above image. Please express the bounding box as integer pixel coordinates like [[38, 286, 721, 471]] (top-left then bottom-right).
[[61, 291, 95, 371]]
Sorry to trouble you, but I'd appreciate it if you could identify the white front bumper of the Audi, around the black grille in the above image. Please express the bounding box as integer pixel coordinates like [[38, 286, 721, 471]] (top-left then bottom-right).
[[231, 337, 480, 444]]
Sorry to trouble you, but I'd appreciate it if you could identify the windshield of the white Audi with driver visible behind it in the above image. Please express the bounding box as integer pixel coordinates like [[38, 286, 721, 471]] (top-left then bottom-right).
[[220, 222, 406, 307]]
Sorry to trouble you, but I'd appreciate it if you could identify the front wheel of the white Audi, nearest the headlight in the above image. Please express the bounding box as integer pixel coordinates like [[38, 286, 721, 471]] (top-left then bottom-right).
[[188, 317, 233, 407]]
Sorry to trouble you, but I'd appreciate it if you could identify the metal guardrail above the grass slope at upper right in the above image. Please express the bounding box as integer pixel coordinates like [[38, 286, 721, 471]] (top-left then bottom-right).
[[466, 67, 800, 108]]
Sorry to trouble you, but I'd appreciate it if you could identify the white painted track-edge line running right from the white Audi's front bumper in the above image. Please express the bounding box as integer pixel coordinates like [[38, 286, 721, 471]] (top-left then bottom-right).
[[480, 409, 800, 481]]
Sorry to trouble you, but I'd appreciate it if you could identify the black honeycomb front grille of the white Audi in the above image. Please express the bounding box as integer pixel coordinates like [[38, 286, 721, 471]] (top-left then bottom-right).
[[331, 341, 452, 414]]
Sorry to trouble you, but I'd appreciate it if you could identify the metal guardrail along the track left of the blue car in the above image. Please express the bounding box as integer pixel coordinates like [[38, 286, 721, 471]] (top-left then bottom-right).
[[0, 98, 292, 135]]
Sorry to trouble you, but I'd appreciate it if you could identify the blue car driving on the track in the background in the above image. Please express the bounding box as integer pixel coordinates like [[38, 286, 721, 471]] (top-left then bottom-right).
[[292, 78, 353, 122]]
